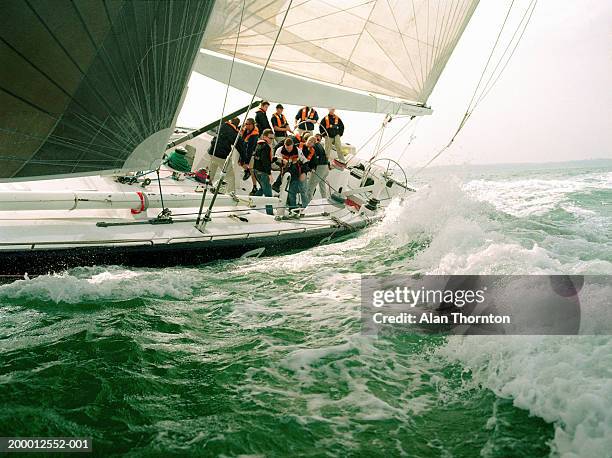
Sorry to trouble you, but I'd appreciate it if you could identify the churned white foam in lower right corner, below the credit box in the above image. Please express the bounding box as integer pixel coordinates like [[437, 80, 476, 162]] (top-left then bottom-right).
[[438, 336, 612, 457]]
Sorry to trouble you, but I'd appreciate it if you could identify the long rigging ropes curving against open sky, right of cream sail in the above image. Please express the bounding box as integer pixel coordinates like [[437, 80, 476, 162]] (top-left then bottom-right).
[[410, 0, 538, 178]]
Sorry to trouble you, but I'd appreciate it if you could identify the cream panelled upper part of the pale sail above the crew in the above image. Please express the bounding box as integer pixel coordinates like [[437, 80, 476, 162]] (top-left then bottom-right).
[[202, 0, 478, 110]]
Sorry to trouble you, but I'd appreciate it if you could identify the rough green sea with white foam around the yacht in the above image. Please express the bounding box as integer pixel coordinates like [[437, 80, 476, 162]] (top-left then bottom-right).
[[0, 162, 612, 457]]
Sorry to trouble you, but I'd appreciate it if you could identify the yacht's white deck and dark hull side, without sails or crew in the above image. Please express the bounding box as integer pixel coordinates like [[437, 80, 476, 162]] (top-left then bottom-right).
[[0, 152, 412, 276]]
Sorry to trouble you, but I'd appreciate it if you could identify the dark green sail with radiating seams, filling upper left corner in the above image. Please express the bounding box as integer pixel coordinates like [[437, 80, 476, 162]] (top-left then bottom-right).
[[0, 0, 214, 179]]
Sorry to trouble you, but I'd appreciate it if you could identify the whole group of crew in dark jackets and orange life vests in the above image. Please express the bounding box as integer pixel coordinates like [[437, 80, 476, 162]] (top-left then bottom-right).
[[204, 101, 345, 215]]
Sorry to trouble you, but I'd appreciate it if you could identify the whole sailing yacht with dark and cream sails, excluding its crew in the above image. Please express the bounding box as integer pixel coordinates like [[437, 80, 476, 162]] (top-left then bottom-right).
[[0, 0, 478, 277]]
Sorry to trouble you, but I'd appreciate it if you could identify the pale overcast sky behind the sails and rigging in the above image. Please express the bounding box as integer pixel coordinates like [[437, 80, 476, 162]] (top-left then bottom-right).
[[178, 0, 612, 166]]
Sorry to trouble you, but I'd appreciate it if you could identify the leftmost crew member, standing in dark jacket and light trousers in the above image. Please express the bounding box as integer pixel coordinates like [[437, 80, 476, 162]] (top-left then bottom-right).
[[208, 118, 245, 192]]
